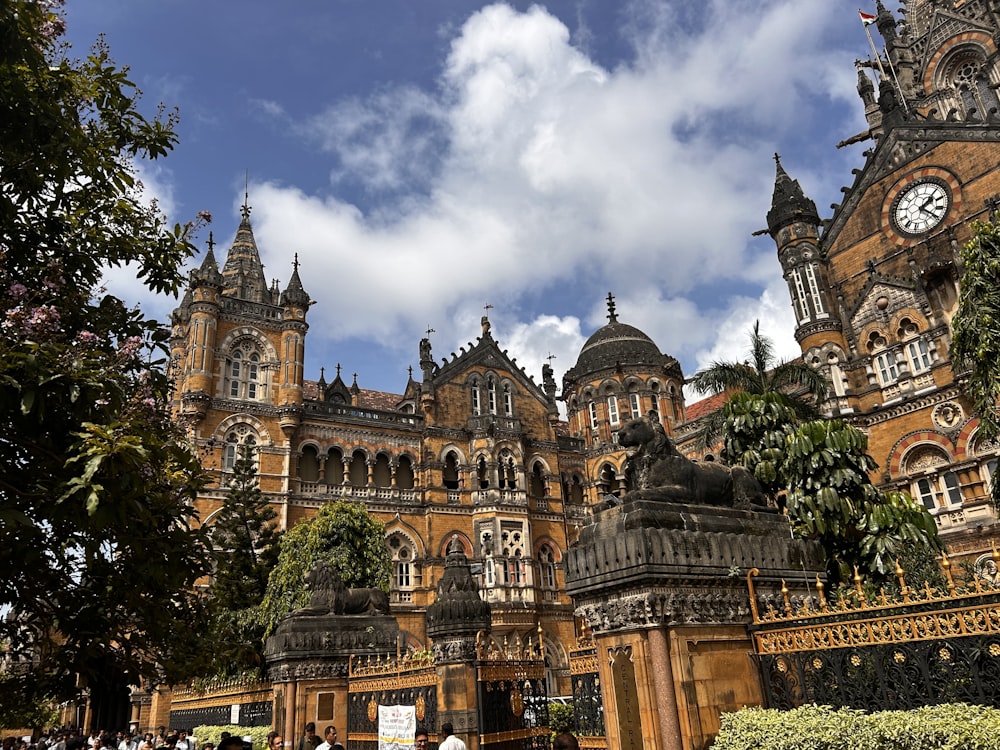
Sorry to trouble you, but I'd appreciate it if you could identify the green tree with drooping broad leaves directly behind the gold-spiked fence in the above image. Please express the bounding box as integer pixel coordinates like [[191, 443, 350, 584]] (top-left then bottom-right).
[[781, 420, 941, 580]]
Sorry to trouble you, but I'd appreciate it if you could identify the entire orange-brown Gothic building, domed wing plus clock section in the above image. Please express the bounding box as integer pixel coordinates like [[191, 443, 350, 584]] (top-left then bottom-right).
[[166, 0, 1000, 724]]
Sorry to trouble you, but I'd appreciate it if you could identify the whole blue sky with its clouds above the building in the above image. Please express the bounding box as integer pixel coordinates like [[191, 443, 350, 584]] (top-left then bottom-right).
[[67, 0, 872, 400]]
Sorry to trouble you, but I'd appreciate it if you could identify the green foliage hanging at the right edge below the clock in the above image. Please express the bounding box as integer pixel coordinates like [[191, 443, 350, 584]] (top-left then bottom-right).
[[951, 222, 1000, 509]]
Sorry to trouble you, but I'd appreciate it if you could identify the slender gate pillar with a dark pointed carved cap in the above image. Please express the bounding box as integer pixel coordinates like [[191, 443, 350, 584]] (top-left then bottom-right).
[[426, 537, 492, 750]]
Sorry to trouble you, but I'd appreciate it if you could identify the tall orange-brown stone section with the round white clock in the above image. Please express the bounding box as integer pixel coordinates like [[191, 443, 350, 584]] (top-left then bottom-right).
[[767, 0, 1000, 559]]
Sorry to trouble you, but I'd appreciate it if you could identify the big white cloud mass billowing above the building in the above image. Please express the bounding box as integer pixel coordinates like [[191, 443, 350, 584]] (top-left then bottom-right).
[[209, 0, 854, 396]]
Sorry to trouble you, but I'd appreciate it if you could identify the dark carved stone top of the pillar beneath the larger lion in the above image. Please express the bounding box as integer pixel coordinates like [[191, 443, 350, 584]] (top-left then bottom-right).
[[565, 500, 823, 632]]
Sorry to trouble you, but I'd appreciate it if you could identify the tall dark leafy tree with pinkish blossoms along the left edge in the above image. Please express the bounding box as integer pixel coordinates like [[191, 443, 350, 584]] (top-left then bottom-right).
[[0, 2, 208, 724]]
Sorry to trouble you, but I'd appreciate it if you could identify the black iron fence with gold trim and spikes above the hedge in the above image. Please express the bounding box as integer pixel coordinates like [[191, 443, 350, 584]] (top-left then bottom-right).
[[747, 558, 1000, 710]]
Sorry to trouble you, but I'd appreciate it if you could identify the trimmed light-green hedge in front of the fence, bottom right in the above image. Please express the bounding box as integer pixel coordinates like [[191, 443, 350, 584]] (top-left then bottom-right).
[[712, 703, 1000, 750]]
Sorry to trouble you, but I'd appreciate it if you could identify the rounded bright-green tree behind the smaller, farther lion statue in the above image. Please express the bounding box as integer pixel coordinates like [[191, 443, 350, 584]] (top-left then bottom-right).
[[257, 499, 392, 636]]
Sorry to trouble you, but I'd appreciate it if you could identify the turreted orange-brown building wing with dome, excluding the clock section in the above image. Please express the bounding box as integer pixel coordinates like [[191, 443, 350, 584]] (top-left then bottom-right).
[[172, 198, 683, 694]]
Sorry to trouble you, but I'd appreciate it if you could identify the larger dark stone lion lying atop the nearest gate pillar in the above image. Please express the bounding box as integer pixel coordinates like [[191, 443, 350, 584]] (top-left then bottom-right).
[[618, 417, 766, 508]]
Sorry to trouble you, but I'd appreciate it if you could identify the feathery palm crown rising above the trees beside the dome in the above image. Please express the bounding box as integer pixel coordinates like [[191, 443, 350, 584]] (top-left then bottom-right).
[[688, 320, 829, 419]]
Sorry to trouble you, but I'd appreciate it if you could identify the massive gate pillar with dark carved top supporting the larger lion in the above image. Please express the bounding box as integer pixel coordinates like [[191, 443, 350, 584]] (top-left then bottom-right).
[[565, 496, 823, 750]]
